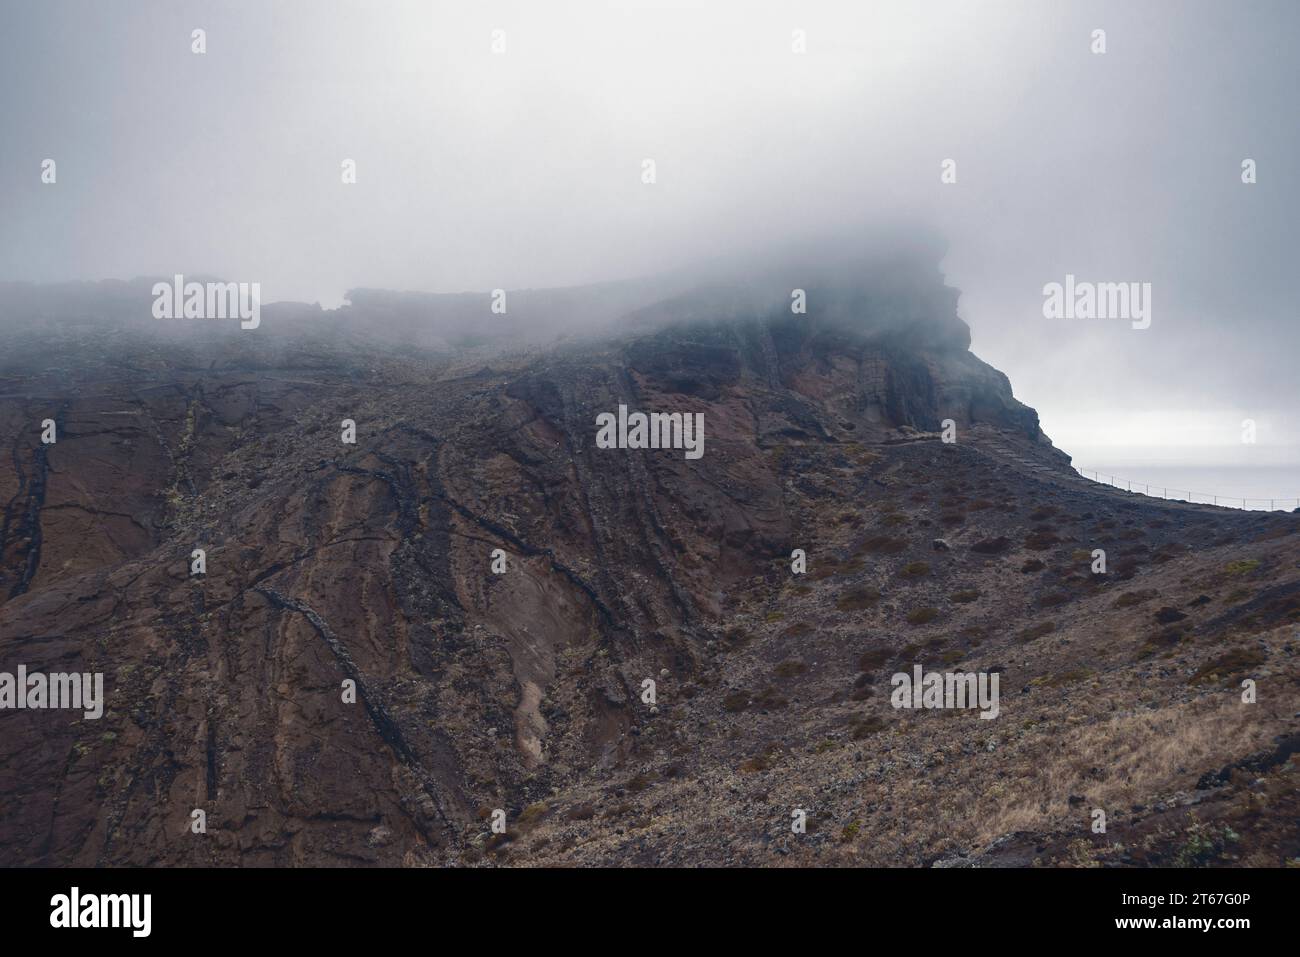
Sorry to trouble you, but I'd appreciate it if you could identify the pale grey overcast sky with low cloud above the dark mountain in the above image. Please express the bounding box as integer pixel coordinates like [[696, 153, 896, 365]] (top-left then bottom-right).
[[0, 0, 1300, 475]]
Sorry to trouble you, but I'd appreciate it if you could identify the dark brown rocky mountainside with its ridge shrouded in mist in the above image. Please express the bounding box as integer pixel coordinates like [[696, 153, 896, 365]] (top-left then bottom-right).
[[0, 256, 1300, 865]]
